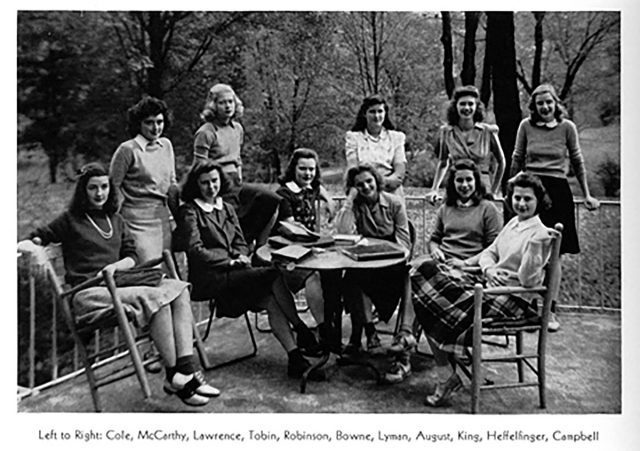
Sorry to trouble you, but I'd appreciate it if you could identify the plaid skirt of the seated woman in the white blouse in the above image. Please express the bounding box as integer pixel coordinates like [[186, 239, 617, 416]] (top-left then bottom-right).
[[411, 261, 536, 356]]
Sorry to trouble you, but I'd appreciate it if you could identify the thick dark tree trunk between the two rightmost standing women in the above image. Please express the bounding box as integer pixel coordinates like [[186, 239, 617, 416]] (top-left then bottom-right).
[[486, 12, 522, 190]]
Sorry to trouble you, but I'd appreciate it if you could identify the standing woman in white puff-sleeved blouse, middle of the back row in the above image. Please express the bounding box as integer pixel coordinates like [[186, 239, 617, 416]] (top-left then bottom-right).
[[345, 94, 407, 197]]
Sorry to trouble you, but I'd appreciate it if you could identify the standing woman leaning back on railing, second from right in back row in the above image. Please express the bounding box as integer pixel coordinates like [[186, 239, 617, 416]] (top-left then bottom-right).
[[427, 86, 505, 204]]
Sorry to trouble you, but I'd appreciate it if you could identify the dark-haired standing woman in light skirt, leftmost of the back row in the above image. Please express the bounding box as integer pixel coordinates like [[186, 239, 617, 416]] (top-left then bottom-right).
[[110, 97, 178, 262]]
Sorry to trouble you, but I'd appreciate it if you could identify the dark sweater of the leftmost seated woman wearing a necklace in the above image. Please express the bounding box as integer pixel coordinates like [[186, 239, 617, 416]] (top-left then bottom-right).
[[30, 211, 138, 285]]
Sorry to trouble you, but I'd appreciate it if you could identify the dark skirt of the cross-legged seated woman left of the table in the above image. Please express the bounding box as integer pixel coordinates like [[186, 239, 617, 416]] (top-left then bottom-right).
[[193, 267, 280, 318]]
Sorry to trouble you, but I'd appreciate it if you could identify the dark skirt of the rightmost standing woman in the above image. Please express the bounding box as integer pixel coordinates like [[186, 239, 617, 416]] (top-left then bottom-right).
[[538, 176, 580, 254]]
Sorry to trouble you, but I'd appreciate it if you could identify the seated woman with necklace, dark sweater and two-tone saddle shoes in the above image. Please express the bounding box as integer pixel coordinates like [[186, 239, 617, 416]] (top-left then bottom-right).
[[18, 163, 220, 406]]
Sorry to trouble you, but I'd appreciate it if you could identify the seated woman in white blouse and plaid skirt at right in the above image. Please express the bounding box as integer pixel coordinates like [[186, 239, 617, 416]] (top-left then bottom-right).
[[411, 174, 551, 407]]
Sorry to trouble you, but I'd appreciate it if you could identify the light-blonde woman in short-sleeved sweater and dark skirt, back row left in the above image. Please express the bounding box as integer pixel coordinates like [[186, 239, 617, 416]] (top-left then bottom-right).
[[193, 83, 280, 249]]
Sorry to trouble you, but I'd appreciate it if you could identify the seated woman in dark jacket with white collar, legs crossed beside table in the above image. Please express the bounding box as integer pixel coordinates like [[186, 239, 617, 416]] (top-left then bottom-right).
[[174, 160, 319, 378]]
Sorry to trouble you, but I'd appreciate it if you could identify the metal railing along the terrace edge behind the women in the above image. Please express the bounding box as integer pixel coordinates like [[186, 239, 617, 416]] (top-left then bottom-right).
[[18, 196, 621, 399]]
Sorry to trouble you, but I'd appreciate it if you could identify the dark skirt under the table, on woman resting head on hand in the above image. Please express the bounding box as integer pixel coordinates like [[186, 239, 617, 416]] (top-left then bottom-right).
[[342, 263, 407, 322]]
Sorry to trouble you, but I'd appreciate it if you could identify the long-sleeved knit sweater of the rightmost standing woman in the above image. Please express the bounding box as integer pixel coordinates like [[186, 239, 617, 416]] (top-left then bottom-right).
[[511, 118, 585, 178]]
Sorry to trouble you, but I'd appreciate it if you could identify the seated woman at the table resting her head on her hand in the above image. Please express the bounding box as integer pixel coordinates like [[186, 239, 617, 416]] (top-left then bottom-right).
[[336, 165, 411, 353]]
